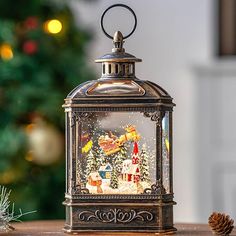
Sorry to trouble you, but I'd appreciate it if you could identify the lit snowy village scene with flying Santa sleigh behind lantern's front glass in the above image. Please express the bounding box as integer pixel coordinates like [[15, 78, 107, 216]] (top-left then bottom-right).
[[77, 112, 156, 194]]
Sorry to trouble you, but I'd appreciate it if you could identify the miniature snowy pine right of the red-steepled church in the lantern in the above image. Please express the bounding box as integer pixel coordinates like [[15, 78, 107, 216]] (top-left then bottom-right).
[[140, 144, 150, 182]]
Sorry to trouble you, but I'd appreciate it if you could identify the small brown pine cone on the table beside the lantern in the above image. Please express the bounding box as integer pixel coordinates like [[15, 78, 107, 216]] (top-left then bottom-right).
[[208, 212, 234, 235]]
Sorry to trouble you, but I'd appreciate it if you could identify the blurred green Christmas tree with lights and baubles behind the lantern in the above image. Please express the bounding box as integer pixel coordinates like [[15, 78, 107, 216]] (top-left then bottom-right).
[[0, 0, 96, 219]]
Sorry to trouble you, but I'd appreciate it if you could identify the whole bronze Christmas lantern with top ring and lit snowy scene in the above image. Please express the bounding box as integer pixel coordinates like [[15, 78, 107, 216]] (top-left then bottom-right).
[[63, 4, 176, 233]]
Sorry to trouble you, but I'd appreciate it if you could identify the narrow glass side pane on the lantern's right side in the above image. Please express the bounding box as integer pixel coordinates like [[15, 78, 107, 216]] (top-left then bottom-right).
[[162, 111, 171, 193]]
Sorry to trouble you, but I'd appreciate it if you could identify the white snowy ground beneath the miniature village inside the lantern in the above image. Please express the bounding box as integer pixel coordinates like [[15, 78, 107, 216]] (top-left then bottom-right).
[[86, 179, 151, 194]]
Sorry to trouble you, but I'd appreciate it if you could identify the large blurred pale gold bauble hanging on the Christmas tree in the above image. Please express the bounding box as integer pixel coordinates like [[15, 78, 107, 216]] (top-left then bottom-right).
[[25, 117, 64, 165]]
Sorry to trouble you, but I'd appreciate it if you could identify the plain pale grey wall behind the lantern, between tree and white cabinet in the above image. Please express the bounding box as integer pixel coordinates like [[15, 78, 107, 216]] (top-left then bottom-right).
[[72, 0, 214, 223]]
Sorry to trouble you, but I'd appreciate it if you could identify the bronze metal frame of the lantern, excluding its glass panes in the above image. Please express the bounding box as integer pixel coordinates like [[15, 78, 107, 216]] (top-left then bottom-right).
[[63, 4, 176, 233]]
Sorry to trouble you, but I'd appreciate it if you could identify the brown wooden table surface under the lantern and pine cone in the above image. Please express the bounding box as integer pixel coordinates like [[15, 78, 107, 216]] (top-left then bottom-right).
[[0, 220, 236, 236]]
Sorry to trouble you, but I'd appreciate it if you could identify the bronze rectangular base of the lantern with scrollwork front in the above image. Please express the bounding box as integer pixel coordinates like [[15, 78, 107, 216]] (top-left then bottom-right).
[[64, 199, 176, 234]]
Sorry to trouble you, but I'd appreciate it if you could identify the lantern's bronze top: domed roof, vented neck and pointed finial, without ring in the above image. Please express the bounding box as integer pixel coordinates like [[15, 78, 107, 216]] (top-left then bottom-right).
[[63, 31, 174, 110]]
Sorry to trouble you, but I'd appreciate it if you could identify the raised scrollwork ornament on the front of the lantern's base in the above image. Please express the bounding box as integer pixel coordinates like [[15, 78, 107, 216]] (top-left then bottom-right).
[[78, 208, 154, 224]]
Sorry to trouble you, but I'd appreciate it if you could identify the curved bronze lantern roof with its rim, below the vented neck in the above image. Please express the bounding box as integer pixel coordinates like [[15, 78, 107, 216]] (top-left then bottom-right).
[[64, 78, 174, 107]]
